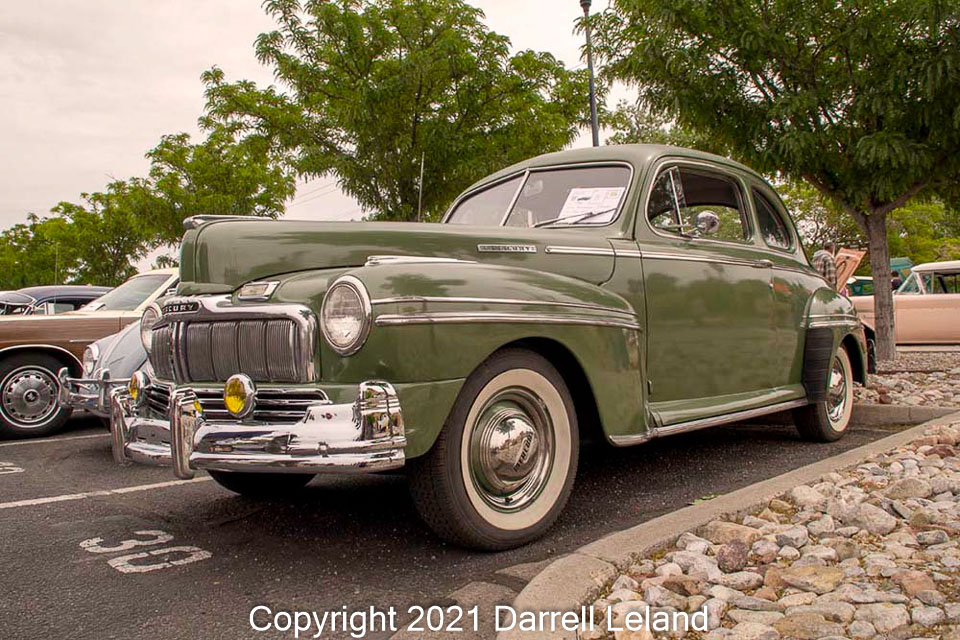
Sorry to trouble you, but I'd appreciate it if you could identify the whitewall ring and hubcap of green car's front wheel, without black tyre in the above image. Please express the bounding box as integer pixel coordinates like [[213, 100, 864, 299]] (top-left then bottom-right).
[[461, 369, 571, 530]]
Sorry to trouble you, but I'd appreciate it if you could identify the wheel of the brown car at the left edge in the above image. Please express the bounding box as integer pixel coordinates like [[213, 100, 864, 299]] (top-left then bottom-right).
[[0, 353, 71, 438]]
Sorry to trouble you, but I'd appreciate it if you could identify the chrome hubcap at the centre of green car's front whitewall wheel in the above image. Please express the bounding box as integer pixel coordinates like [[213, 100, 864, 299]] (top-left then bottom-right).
[[470, 389, 554, 511]]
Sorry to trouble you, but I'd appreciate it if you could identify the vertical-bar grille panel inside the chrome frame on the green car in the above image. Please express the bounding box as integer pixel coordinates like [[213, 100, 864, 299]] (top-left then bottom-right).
[[150, 318, 308, 382]]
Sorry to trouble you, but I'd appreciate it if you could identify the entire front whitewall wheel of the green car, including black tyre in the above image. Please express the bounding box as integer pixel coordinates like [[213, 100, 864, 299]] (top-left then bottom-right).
[[410, 349, 579, 551]]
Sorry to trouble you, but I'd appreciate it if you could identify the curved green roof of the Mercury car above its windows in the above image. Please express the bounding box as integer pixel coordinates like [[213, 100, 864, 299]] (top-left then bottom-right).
[[467, 144, 764, 191]]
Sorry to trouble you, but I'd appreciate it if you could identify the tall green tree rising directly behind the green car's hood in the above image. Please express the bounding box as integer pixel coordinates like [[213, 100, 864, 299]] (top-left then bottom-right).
[[202, 0, 588, 220]]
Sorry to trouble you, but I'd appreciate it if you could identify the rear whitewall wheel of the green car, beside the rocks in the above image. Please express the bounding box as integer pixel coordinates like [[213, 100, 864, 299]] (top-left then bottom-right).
[[793, 346, 853, 442]]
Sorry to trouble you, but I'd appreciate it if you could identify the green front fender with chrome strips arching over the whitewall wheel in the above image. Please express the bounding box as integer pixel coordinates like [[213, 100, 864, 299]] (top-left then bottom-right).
[[320, 262, 643, 456]]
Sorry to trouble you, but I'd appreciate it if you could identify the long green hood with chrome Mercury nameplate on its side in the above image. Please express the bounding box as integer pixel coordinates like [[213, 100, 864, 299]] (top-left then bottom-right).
[[180, 220, 614, 294]]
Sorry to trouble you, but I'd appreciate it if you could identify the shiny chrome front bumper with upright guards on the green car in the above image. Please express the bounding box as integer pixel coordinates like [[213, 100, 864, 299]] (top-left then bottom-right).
[[110, 381, 406, 479]]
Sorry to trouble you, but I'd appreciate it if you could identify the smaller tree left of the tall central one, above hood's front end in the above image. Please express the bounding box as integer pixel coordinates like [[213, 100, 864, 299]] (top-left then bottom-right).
[[133, 126, 296, 247]]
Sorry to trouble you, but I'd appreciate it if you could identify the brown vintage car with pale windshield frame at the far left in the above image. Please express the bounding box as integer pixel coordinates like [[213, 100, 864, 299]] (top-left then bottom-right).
[[0, 269, 179, 437]]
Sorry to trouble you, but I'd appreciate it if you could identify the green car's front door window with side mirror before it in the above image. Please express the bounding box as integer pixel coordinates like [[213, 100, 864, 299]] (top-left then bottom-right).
[[647, 166, 750, 242]]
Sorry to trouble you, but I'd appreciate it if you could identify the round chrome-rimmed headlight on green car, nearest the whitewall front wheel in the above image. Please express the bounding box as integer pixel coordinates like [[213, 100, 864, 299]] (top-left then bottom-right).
[[320, 276, 370, 356]]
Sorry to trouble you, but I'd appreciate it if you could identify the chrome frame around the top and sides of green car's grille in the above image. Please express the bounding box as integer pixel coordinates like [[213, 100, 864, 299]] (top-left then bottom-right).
[[154, 294, 319, 383]]
